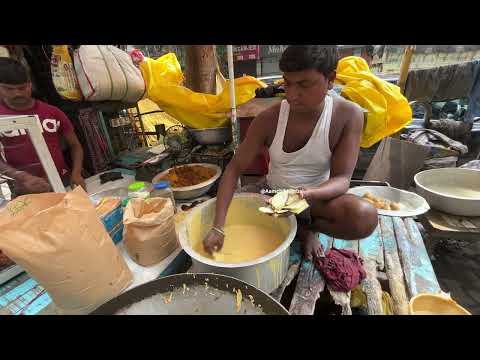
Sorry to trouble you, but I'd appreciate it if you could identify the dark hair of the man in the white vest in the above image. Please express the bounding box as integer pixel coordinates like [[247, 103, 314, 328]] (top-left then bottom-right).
[[279, 45, 338, 76]]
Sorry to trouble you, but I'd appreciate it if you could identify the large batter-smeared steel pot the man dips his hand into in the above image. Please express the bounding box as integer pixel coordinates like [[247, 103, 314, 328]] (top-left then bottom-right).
[[178, 193, 297, 294]]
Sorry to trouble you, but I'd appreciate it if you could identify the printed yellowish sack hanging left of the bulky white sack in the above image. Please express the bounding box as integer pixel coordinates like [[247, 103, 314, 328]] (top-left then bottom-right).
[[50, 45, 83, 101]]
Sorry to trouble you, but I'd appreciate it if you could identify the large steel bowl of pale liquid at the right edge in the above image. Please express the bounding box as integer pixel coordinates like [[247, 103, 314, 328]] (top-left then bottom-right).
[[414, 168, 480, 216]]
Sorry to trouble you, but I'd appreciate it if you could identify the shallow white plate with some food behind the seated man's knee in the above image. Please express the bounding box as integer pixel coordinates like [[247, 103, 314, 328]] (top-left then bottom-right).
[[348, 186, 430, 217]]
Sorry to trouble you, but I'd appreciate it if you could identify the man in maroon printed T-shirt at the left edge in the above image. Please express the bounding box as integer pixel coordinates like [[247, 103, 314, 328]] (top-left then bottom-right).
[[0, 58, 86, 193]]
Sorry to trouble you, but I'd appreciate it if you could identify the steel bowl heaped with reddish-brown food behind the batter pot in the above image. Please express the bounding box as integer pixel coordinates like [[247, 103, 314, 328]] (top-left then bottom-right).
[[152, 163, 222, 200]]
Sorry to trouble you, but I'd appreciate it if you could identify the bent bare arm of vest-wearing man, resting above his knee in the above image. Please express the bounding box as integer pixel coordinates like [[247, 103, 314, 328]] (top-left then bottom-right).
[[302, 107, 363, 200]]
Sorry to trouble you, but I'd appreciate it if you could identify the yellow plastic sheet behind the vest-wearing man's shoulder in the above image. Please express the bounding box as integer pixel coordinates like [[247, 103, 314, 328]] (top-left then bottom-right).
[[336, 56, 412, 148]]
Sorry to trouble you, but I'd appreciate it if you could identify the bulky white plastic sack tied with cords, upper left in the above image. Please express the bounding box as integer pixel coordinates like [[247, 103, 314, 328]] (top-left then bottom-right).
[[74, 45, 145, 103]]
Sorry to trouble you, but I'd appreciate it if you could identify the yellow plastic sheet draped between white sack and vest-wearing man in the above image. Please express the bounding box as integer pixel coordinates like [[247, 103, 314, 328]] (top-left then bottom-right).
[[140, 53, 264, 129]]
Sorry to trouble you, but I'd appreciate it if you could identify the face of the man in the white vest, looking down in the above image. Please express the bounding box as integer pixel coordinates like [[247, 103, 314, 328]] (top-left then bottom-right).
[[283, 70, 335, 112]]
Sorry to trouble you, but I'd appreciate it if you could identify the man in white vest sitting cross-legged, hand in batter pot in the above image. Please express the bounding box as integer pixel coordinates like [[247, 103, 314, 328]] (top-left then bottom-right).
[[204, 45, 378, 260]]
